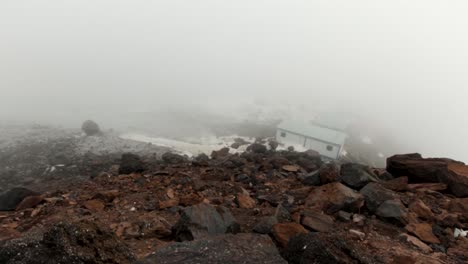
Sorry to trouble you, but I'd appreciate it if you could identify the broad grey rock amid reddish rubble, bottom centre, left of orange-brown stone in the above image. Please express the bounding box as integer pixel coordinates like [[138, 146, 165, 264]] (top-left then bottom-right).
[[173, 203, 240, 241]]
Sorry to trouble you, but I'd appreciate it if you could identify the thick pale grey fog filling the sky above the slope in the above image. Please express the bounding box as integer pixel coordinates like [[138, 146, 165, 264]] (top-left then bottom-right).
[[0, 0, 468, 162]]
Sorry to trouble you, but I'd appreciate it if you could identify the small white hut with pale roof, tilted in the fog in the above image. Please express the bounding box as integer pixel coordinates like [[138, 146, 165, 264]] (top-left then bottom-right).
[[276, 120, 347, 159]]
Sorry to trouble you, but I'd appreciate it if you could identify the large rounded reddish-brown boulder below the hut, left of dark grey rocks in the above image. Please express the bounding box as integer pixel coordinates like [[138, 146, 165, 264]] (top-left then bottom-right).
[[305, 182, 364, 214]]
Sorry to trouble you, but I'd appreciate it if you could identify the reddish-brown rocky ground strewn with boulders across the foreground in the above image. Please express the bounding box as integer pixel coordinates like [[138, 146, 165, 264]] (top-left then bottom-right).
[[0, 125, 468, 264]]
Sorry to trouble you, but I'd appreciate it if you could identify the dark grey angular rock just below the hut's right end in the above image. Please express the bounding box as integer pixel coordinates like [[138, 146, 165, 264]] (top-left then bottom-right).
[[340, 163, 377, 190]]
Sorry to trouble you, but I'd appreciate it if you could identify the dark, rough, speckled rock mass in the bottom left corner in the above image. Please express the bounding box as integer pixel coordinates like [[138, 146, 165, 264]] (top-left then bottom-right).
[[0, 221, 134, 264]]
